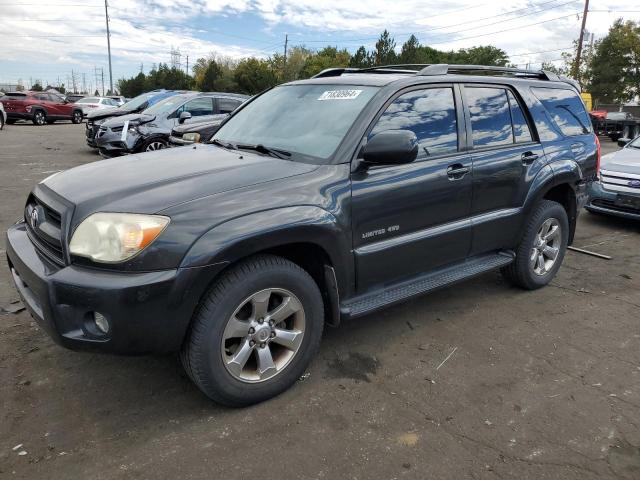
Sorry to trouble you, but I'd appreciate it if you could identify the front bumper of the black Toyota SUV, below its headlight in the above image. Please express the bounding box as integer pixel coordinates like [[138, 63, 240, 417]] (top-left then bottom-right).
[[6, 223, 223, 354]]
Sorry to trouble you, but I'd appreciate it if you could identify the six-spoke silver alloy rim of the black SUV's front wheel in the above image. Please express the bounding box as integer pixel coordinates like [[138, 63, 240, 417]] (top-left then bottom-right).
[[221, 288, 305, 383]]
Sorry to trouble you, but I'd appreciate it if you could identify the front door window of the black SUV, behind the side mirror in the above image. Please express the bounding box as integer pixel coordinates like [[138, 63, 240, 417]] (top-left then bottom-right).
[[369, 88, 458, 158]]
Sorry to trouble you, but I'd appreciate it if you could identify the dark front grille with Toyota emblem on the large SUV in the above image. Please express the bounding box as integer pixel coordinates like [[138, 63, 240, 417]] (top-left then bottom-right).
[[24, 195, 64, 265]]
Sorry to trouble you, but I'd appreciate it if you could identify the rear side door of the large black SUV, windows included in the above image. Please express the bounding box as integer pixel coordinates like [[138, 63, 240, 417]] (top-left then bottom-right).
[[463, 84, 546, 255]]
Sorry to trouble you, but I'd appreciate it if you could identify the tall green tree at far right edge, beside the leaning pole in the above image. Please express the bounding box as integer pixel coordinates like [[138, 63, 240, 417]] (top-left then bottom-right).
[[588, 19, 640, 103]]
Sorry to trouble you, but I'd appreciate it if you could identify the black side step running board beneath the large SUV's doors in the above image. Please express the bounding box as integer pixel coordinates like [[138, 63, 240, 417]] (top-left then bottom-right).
[[340, 252, 515, 318]]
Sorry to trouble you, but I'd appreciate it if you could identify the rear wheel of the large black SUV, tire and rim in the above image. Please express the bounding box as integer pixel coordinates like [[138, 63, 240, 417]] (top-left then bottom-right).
[[502, 200, 569, 290]]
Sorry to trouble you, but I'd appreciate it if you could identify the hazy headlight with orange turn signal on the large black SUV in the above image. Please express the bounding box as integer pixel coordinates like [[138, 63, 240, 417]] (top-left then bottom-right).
[[69, 213, 169, 263]]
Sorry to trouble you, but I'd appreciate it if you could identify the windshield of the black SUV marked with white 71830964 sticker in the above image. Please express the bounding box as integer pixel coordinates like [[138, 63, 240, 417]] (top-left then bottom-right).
[[215, 84, 379, 160]]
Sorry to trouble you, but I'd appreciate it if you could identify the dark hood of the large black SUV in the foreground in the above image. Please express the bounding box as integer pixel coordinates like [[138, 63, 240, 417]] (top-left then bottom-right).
[[44, 145, 318, 222]]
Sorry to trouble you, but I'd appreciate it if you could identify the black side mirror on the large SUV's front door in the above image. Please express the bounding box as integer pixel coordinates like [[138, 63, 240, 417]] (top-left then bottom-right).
[[362, 130, 418, 165]]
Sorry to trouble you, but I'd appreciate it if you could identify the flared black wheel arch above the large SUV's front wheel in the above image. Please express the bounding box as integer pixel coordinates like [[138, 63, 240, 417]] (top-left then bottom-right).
[[180, 205, 353, 290]]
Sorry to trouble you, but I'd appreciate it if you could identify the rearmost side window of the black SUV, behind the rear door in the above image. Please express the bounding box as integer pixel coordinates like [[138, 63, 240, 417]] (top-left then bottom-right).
[[531, 88, 591, 136]]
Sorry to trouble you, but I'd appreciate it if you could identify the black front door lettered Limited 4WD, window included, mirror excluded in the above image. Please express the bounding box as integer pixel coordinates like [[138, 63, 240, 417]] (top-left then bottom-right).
[[352, 85, 472, 292]]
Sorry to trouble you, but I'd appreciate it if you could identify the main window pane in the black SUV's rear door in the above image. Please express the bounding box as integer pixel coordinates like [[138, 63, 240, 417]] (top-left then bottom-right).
[[465, 87, 513, 147]]
